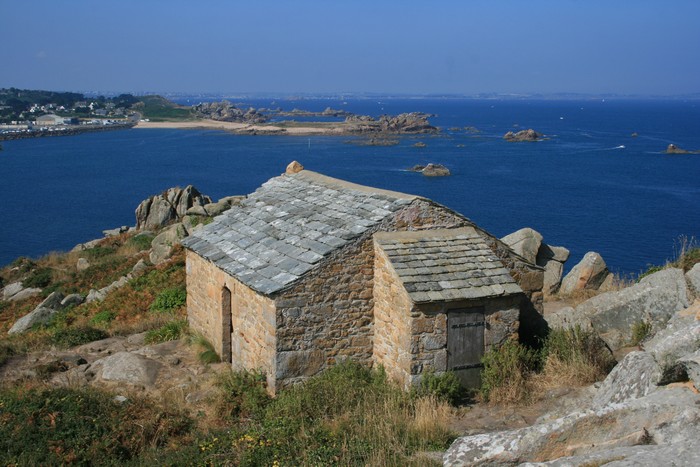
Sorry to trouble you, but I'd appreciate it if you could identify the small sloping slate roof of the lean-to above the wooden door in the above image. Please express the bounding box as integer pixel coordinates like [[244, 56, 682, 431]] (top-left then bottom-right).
[[374, 227, 522, 303]]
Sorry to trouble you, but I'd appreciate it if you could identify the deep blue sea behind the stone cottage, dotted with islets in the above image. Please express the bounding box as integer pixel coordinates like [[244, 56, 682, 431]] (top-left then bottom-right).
[[0, 98, 700, 274]]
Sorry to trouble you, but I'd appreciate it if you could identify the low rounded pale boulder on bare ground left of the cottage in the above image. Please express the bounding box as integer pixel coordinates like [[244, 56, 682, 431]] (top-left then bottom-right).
[[93, 352, 162, 386]]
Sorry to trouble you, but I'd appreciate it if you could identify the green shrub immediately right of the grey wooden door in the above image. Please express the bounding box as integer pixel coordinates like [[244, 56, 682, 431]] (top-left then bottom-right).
[[479, 340, 540, 404]]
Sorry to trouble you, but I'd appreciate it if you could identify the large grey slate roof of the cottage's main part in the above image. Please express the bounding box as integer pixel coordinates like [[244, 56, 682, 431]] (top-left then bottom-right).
[[182, 170, 417, 295]]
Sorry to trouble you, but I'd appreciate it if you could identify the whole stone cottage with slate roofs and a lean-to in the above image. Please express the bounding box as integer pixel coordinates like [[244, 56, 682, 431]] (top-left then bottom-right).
[[183, 164, 543, 392]]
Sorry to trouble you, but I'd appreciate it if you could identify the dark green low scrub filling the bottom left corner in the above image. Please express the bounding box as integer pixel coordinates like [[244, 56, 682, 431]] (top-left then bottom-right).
[[0, 384, 194, 465]]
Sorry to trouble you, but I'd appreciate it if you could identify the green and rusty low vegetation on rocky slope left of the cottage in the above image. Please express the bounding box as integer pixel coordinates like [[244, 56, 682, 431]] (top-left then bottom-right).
[[0, 234, 187, 365]]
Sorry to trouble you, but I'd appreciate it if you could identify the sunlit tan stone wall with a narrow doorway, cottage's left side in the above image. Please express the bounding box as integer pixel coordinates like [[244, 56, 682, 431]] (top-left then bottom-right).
[[187, 250, 277, 392]]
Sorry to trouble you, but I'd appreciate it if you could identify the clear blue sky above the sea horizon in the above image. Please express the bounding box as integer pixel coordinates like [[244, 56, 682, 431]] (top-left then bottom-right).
[[0, 0, 700, 95]]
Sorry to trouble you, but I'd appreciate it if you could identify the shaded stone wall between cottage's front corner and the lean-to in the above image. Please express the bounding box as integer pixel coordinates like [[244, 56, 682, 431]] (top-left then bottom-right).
[[275, 232, 374, 385]]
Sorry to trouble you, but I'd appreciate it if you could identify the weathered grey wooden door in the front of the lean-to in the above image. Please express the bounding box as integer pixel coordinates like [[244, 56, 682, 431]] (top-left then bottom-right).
[[447, 307, 486, 388]]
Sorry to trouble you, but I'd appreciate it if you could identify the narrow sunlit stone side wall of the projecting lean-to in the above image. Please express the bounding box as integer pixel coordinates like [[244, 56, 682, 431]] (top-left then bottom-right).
[[373, 245, 413, 389]]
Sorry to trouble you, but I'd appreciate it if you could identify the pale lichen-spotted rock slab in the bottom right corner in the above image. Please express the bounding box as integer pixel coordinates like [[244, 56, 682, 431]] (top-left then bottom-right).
[[443, 388, 700, 466]]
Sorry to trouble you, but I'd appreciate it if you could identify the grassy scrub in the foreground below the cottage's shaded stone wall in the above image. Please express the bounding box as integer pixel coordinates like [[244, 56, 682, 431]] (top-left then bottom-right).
[[199, 363, 454, 465]]
